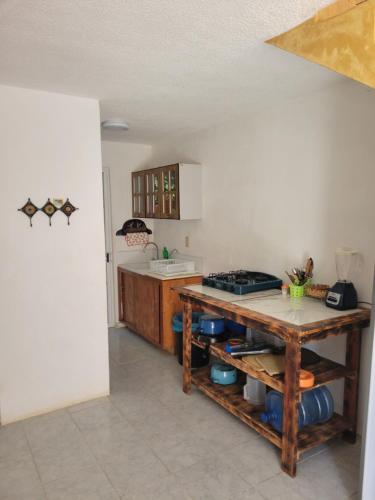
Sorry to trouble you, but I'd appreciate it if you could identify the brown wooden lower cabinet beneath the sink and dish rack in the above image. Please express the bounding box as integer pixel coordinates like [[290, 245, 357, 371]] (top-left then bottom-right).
[[117, 267, 202, 353]]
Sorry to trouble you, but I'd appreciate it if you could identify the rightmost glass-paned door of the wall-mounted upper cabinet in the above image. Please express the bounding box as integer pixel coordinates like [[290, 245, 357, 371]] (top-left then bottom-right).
[[160, 164, 179, 219]]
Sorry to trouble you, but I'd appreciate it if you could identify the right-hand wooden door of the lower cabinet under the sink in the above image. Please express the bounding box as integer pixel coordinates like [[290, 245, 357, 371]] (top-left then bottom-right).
[[135, 276, 160, 344]]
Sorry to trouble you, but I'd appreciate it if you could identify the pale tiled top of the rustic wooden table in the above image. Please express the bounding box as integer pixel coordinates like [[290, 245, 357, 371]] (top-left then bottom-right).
[[184, 285, 368, 326]]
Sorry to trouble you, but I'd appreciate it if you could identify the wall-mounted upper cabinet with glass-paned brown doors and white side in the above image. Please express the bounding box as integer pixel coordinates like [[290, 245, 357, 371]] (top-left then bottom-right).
[[132, 163, 202, 220]]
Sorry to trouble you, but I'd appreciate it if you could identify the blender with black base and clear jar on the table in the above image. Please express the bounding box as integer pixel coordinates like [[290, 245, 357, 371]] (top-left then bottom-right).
[[326, 248, 358, 311]]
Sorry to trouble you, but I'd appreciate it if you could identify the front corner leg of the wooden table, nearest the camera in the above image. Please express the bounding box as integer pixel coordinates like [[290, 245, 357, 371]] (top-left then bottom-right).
[[281, 342, 301, 477]]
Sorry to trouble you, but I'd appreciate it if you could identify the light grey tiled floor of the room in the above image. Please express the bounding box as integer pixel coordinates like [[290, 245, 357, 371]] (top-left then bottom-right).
[[0, 329, 360, 500]]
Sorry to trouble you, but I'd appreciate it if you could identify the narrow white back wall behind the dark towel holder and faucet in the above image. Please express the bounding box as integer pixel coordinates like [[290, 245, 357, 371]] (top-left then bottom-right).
[[102, 141, 153, 321]]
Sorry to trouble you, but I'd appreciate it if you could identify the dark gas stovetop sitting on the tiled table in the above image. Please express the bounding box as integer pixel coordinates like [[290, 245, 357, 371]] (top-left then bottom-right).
[[203, 270, 282, 295]]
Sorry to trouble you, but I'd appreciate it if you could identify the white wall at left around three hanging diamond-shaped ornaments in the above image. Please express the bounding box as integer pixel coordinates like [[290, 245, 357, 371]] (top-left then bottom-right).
[[0, 87, 109, 424]]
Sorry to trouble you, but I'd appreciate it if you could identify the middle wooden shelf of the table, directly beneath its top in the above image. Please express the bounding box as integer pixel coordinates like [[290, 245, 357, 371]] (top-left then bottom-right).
[[192, 337, 355, 392]]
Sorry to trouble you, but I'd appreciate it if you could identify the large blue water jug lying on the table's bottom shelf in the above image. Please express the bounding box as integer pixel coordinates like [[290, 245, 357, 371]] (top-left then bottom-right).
[[260, 386, 334, 432]]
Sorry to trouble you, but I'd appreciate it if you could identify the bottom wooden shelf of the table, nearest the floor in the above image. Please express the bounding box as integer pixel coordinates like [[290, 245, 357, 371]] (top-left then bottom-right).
[[192, 368, 352, 455]]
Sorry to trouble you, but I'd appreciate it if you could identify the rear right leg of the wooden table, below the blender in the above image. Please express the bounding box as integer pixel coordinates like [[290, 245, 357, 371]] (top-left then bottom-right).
[[343, 328, 362, 444]]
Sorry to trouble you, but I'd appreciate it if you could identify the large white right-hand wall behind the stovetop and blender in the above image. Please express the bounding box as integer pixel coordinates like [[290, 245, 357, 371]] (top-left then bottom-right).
[[152, 82, 375, 432]]
